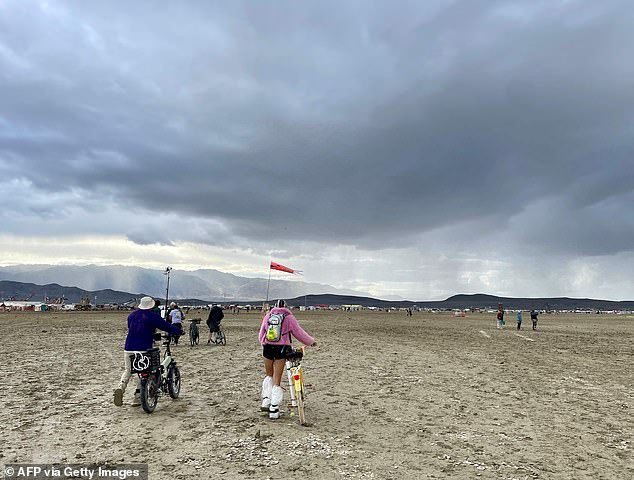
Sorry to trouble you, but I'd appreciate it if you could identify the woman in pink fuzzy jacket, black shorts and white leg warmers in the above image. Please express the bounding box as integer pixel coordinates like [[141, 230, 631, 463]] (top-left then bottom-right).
[[260, 300, 317, 419]]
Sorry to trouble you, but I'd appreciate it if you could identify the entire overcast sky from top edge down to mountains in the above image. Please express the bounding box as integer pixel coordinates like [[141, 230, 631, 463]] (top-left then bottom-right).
[[0, 0, 634, 300]]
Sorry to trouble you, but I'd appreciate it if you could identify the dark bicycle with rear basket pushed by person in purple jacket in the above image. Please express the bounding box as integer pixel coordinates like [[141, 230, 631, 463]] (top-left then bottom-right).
[[130, 334, 181, 413]]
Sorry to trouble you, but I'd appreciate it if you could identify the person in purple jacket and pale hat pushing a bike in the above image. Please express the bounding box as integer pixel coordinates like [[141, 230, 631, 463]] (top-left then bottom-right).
[[114, 297, 183, 407]]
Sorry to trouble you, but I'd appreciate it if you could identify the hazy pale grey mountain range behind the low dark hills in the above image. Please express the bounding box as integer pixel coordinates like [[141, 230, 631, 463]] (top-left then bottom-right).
[[0, 265, 370, 303]]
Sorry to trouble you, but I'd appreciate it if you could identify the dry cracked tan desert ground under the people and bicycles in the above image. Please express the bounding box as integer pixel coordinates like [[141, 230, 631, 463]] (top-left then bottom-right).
[[0, 311, 634, 480]]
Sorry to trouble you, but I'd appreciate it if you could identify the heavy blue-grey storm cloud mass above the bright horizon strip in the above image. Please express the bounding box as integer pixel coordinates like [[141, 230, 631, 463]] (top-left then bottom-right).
[[0, 1, 634, 254]]
